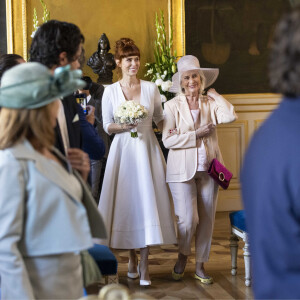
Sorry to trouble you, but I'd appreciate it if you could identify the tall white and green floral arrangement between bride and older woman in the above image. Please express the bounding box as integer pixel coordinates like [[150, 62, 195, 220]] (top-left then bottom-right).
[[145, 10, 177, 103]]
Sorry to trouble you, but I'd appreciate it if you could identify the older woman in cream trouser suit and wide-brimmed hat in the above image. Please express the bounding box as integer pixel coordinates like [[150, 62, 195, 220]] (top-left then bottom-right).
[[163, 55, 236, 284]]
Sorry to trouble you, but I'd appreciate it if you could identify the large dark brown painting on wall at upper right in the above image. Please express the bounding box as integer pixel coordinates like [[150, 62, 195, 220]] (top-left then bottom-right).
[[185, 0, 299, 94]]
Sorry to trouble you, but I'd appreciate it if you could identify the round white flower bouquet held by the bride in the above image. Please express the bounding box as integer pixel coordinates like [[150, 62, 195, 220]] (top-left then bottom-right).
[[114, 100, 148, 138]]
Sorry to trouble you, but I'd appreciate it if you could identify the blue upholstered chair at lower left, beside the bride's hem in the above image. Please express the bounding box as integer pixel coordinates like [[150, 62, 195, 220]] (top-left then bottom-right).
[[88, 244, 119, 284]]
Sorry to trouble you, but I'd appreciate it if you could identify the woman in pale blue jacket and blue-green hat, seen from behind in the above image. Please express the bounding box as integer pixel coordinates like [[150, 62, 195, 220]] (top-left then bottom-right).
[[0, 63, 106, 299]]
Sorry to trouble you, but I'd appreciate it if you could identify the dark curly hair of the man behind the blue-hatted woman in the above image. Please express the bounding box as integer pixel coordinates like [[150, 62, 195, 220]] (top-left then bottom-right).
[[30, 20, 84, 68]]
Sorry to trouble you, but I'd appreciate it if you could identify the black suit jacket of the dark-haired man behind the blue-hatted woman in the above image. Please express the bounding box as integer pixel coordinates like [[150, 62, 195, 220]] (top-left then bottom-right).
[[55, 95, 82, 155]]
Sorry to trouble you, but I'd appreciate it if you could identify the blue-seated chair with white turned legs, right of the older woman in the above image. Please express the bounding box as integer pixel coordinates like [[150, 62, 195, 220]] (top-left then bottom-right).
[[229, 210, 251, 286]]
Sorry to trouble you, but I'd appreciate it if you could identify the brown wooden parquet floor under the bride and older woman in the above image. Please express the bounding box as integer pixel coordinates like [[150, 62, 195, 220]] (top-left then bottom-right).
[[88, 212, 253, 300]]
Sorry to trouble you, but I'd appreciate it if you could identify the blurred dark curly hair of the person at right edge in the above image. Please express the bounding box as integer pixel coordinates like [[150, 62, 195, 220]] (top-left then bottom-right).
[[269, 6, 300, 98]]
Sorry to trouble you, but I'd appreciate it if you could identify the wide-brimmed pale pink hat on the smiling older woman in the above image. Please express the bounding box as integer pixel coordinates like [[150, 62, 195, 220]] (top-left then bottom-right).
[[169, 55, 219, 93]]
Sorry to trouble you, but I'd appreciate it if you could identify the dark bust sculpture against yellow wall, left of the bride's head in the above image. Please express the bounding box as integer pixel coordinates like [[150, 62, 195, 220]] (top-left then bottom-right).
[[87, 33, 116, 84]]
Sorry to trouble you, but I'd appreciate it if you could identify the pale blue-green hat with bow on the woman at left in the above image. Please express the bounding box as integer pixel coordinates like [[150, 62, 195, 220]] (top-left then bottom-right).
[[0, 62, 86, 109]]
